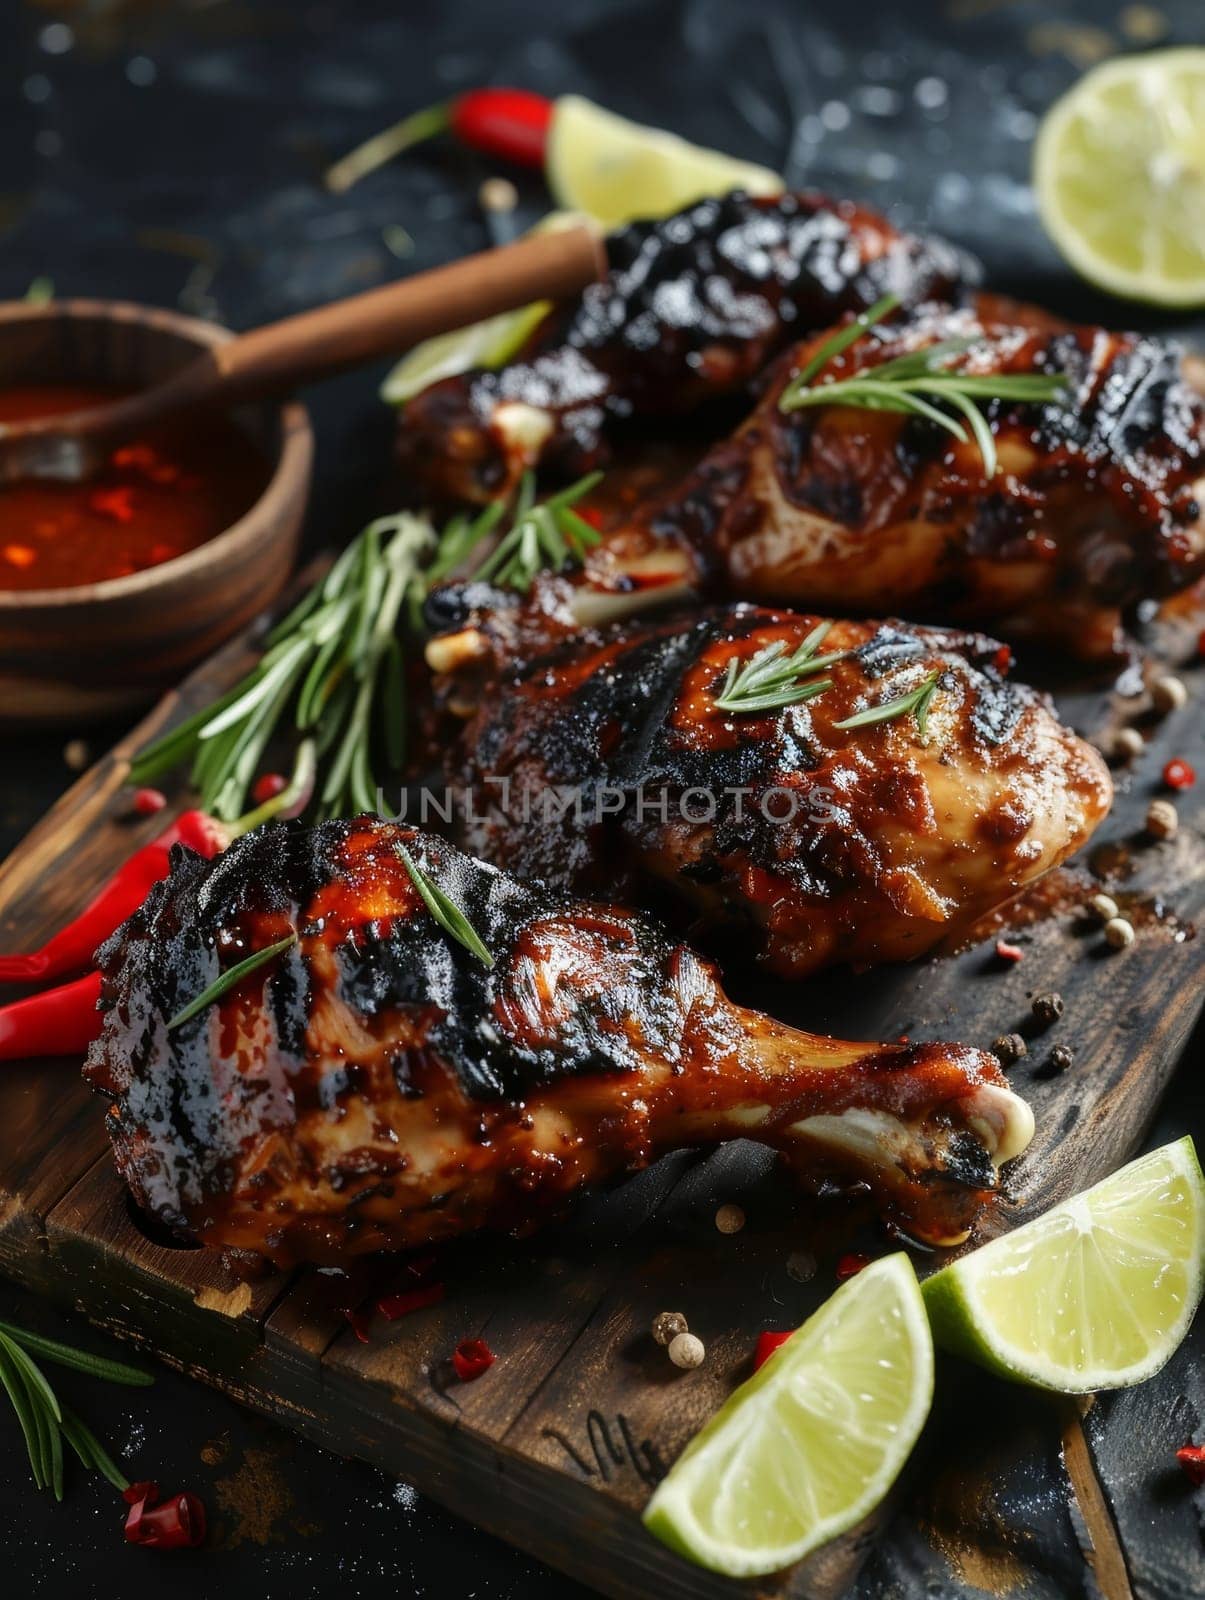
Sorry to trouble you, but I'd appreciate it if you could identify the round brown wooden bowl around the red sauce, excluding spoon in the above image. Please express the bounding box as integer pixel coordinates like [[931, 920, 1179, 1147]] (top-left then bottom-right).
[[0, 301, 314, 725]]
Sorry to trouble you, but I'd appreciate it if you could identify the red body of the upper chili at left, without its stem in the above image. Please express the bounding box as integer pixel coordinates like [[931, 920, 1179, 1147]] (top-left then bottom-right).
[[0, 811, 226, 984]]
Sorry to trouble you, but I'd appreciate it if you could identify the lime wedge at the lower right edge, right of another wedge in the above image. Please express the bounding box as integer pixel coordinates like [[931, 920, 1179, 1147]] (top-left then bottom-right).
[[925, 1139, 1205, 1394]]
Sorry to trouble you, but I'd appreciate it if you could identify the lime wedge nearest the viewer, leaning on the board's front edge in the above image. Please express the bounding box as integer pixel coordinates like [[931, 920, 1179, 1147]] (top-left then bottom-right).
[[645, 1254, 933, 1578]]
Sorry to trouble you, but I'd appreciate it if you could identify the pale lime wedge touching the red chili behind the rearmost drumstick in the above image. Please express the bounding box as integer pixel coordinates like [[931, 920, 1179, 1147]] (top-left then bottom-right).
[[544, 94, 783, 229]]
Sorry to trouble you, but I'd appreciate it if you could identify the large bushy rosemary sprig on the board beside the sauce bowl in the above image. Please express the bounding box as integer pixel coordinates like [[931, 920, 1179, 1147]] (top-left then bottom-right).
[[128, 474, 600, 826]]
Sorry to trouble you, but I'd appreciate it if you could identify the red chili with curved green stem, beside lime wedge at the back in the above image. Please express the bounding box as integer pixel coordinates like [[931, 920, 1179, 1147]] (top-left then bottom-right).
[[326, 90, 555, 194]]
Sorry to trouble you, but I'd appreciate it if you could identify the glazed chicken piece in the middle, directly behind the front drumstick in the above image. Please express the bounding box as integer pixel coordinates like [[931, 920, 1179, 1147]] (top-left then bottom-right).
[[445, 605, 1112, 978]]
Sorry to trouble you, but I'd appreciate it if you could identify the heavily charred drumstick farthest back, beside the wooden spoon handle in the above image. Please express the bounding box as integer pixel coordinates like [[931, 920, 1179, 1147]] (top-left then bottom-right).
[[397, 194, 978, 502]]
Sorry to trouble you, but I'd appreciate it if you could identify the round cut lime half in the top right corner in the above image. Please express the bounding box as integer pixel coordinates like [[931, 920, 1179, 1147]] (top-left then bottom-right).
[[1034, 48, 1205, 306]]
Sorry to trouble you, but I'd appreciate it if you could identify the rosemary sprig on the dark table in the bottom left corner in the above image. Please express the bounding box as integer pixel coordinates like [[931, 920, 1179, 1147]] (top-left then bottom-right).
[[0, 1322, 154, 1501]]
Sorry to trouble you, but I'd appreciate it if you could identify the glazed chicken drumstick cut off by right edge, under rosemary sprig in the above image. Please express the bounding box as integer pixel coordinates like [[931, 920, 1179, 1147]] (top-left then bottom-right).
[[508, 296, 1205, 659]]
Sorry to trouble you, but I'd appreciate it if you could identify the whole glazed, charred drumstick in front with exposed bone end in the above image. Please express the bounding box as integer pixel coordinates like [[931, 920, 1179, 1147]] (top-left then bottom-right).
[[85, 818, 1034, 1267]]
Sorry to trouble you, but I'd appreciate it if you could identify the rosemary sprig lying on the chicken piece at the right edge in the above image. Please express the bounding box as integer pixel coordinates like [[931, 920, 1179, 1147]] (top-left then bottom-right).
[[778, 294, 1066, 478]]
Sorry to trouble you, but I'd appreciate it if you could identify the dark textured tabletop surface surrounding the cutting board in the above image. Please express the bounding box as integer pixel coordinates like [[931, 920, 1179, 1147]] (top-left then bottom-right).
[[0, 0, 1205, 1600]]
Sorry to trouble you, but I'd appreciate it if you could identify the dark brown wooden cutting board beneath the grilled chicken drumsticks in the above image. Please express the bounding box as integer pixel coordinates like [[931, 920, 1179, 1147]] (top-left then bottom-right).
[[0, 601, 1205, 1600]]
